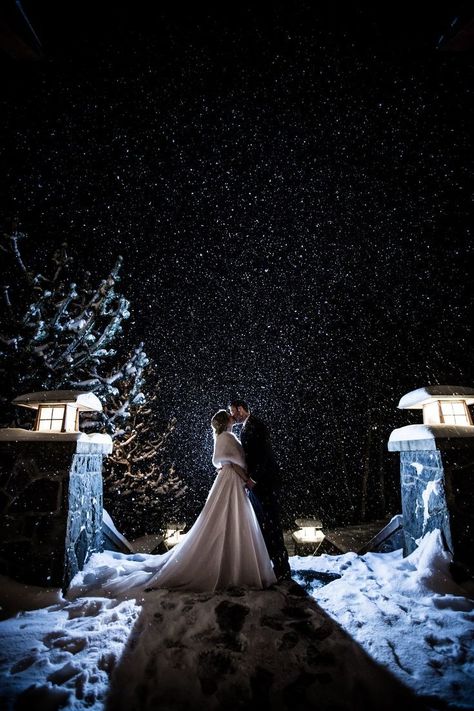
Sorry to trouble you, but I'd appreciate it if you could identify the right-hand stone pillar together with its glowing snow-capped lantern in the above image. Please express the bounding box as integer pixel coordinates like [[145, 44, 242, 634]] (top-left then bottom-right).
[[388, 385, 474, 576]]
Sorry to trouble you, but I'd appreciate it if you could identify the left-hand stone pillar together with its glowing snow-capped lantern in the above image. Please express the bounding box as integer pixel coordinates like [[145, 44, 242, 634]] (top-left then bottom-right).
[[0, 390, 112, 589]]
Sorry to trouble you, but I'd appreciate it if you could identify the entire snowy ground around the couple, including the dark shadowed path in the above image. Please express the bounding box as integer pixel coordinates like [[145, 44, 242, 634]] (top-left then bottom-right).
[[0, 531, 474, 711]]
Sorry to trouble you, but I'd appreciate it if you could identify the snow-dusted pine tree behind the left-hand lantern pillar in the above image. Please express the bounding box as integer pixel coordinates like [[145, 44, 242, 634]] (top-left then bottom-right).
[[0, 228, 186, 537]]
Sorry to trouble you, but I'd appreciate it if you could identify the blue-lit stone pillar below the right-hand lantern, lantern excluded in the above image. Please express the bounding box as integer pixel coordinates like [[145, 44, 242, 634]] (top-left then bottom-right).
[[389, 434, 474, 574]]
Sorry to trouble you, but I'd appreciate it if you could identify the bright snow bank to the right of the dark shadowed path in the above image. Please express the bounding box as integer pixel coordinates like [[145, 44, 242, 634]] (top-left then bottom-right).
[[291, 530, 474, 709]]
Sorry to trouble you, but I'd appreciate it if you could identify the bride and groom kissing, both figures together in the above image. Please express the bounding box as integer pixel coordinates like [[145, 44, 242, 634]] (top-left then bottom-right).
[[130, 400, 291, 592]]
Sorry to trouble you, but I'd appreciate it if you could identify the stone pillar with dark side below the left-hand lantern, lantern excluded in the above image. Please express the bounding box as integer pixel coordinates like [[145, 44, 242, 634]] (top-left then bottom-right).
[[0, 435, 110, 590]]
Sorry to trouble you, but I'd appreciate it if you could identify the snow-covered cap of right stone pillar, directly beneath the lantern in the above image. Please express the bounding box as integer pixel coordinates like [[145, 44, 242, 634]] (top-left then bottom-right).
[[388, 424, 474, 452]]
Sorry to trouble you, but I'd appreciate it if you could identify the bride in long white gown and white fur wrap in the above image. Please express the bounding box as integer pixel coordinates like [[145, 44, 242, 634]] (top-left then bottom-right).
[[143, 410, 276, 591]]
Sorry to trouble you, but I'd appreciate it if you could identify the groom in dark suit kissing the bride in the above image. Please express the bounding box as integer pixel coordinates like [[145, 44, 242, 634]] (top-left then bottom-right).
[[229, 400, 291, 582]]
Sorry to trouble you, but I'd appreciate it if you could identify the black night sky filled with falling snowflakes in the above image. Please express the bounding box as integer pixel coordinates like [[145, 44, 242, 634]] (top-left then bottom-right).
[[0, 0, 474, 524]]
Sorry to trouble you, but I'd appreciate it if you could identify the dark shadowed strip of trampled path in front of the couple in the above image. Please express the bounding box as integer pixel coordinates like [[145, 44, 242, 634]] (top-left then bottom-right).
[[103, 582, 424, 711]]
